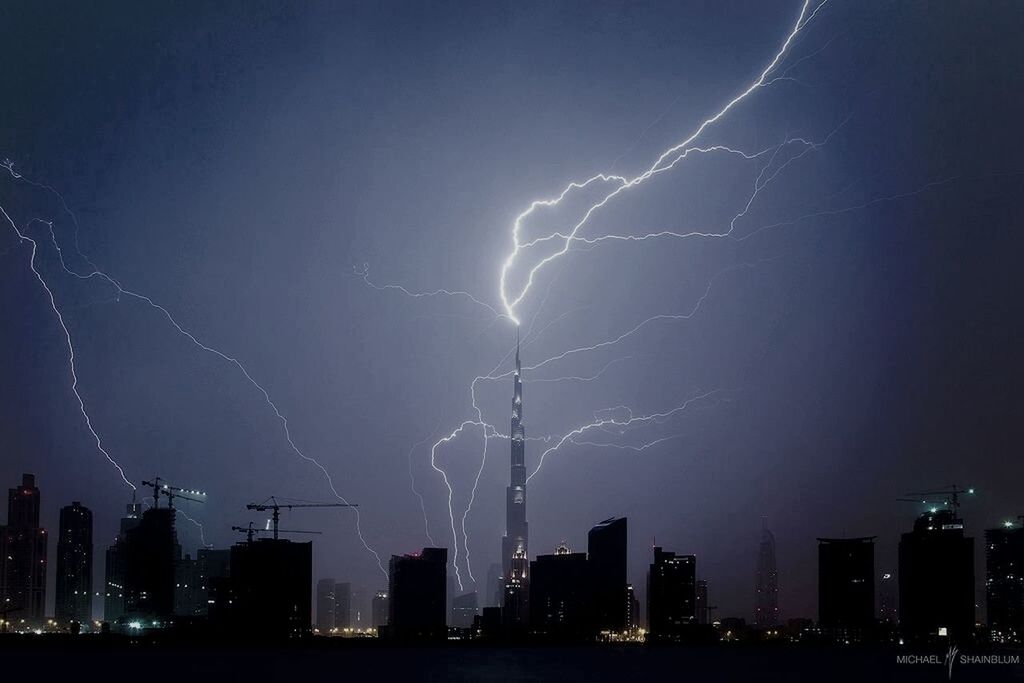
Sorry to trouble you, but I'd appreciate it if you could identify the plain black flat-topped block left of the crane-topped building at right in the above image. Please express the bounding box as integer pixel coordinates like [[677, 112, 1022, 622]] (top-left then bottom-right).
[[818, 537, 874, 641]]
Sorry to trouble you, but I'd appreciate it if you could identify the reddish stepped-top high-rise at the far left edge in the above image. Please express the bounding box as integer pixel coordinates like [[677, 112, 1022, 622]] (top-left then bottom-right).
[[0, 474, 46, 624]]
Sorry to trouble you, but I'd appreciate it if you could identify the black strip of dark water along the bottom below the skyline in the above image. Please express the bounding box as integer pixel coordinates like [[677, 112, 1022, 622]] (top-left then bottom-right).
[[0, 638, 1024, 683]]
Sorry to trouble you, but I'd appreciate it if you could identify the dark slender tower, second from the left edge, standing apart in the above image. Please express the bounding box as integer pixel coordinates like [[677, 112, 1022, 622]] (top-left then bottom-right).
[[54, 501, 92, 627]]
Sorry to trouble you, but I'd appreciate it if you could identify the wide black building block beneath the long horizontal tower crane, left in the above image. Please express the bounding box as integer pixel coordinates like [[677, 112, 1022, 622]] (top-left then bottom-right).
[[227, 539, 313, 638]]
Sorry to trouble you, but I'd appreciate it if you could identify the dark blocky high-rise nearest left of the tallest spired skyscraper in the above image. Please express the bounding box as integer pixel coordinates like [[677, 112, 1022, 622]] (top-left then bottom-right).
[[388, 548, 447, 640]]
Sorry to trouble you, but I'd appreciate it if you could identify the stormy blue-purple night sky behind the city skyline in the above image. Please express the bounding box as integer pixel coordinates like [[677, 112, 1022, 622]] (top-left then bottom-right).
[[0, 0, 1024, 618]]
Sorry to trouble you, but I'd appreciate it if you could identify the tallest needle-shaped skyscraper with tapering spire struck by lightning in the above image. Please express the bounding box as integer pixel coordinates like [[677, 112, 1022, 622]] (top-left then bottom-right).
[[501, 329, 529, 628]]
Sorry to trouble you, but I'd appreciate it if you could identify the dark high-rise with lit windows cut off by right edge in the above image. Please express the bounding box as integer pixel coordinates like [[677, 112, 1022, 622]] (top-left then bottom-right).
[[985, 522, 1024, 642]]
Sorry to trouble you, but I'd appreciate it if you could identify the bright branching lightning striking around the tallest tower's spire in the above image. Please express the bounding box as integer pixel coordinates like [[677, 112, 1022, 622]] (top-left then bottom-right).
[[356, 0, 966, 590]]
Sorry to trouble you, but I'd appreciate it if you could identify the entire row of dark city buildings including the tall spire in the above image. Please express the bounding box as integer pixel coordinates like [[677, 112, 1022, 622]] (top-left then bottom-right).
[[0, 339, 1024, 643]]
